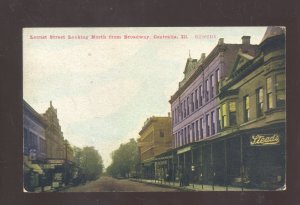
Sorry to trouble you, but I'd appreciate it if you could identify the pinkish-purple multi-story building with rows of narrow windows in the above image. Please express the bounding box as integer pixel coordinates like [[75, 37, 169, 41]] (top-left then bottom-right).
[[169, 36, 257, 186]]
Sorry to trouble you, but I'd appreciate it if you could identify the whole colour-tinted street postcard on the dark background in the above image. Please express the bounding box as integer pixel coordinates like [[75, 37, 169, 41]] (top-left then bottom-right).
[[22, 26, 287, 193]]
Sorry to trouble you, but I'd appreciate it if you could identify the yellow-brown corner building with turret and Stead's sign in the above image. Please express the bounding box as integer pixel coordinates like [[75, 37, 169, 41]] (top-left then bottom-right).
[[218, 27, 286, 188]]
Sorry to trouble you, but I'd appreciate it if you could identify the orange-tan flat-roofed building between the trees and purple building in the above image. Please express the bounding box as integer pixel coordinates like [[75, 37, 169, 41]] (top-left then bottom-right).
[[138, 116, 172, 178]]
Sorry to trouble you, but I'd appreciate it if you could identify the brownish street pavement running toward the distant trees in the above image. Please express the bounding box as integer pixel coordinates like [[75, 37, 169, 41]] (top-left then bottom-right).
[[62, 176, 179, 192]]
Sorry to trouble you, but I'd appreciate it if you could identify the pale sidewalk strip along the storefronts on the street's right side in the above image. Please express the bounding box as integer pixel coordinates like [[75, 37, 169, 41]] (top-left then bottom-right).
[[130, 179, 263, 191]]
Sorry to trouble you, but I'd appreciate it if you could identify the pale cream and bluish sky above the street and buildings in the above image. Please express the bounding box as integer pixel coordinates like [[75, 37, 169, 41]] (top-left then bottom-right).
[[23, 27, 266, 167]]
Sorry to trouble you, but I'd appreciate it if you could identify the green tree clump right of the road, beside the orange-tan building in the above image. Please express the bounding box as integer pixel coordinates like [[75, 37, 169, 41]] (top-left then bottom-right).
[[107, 139, 138, 177]]
